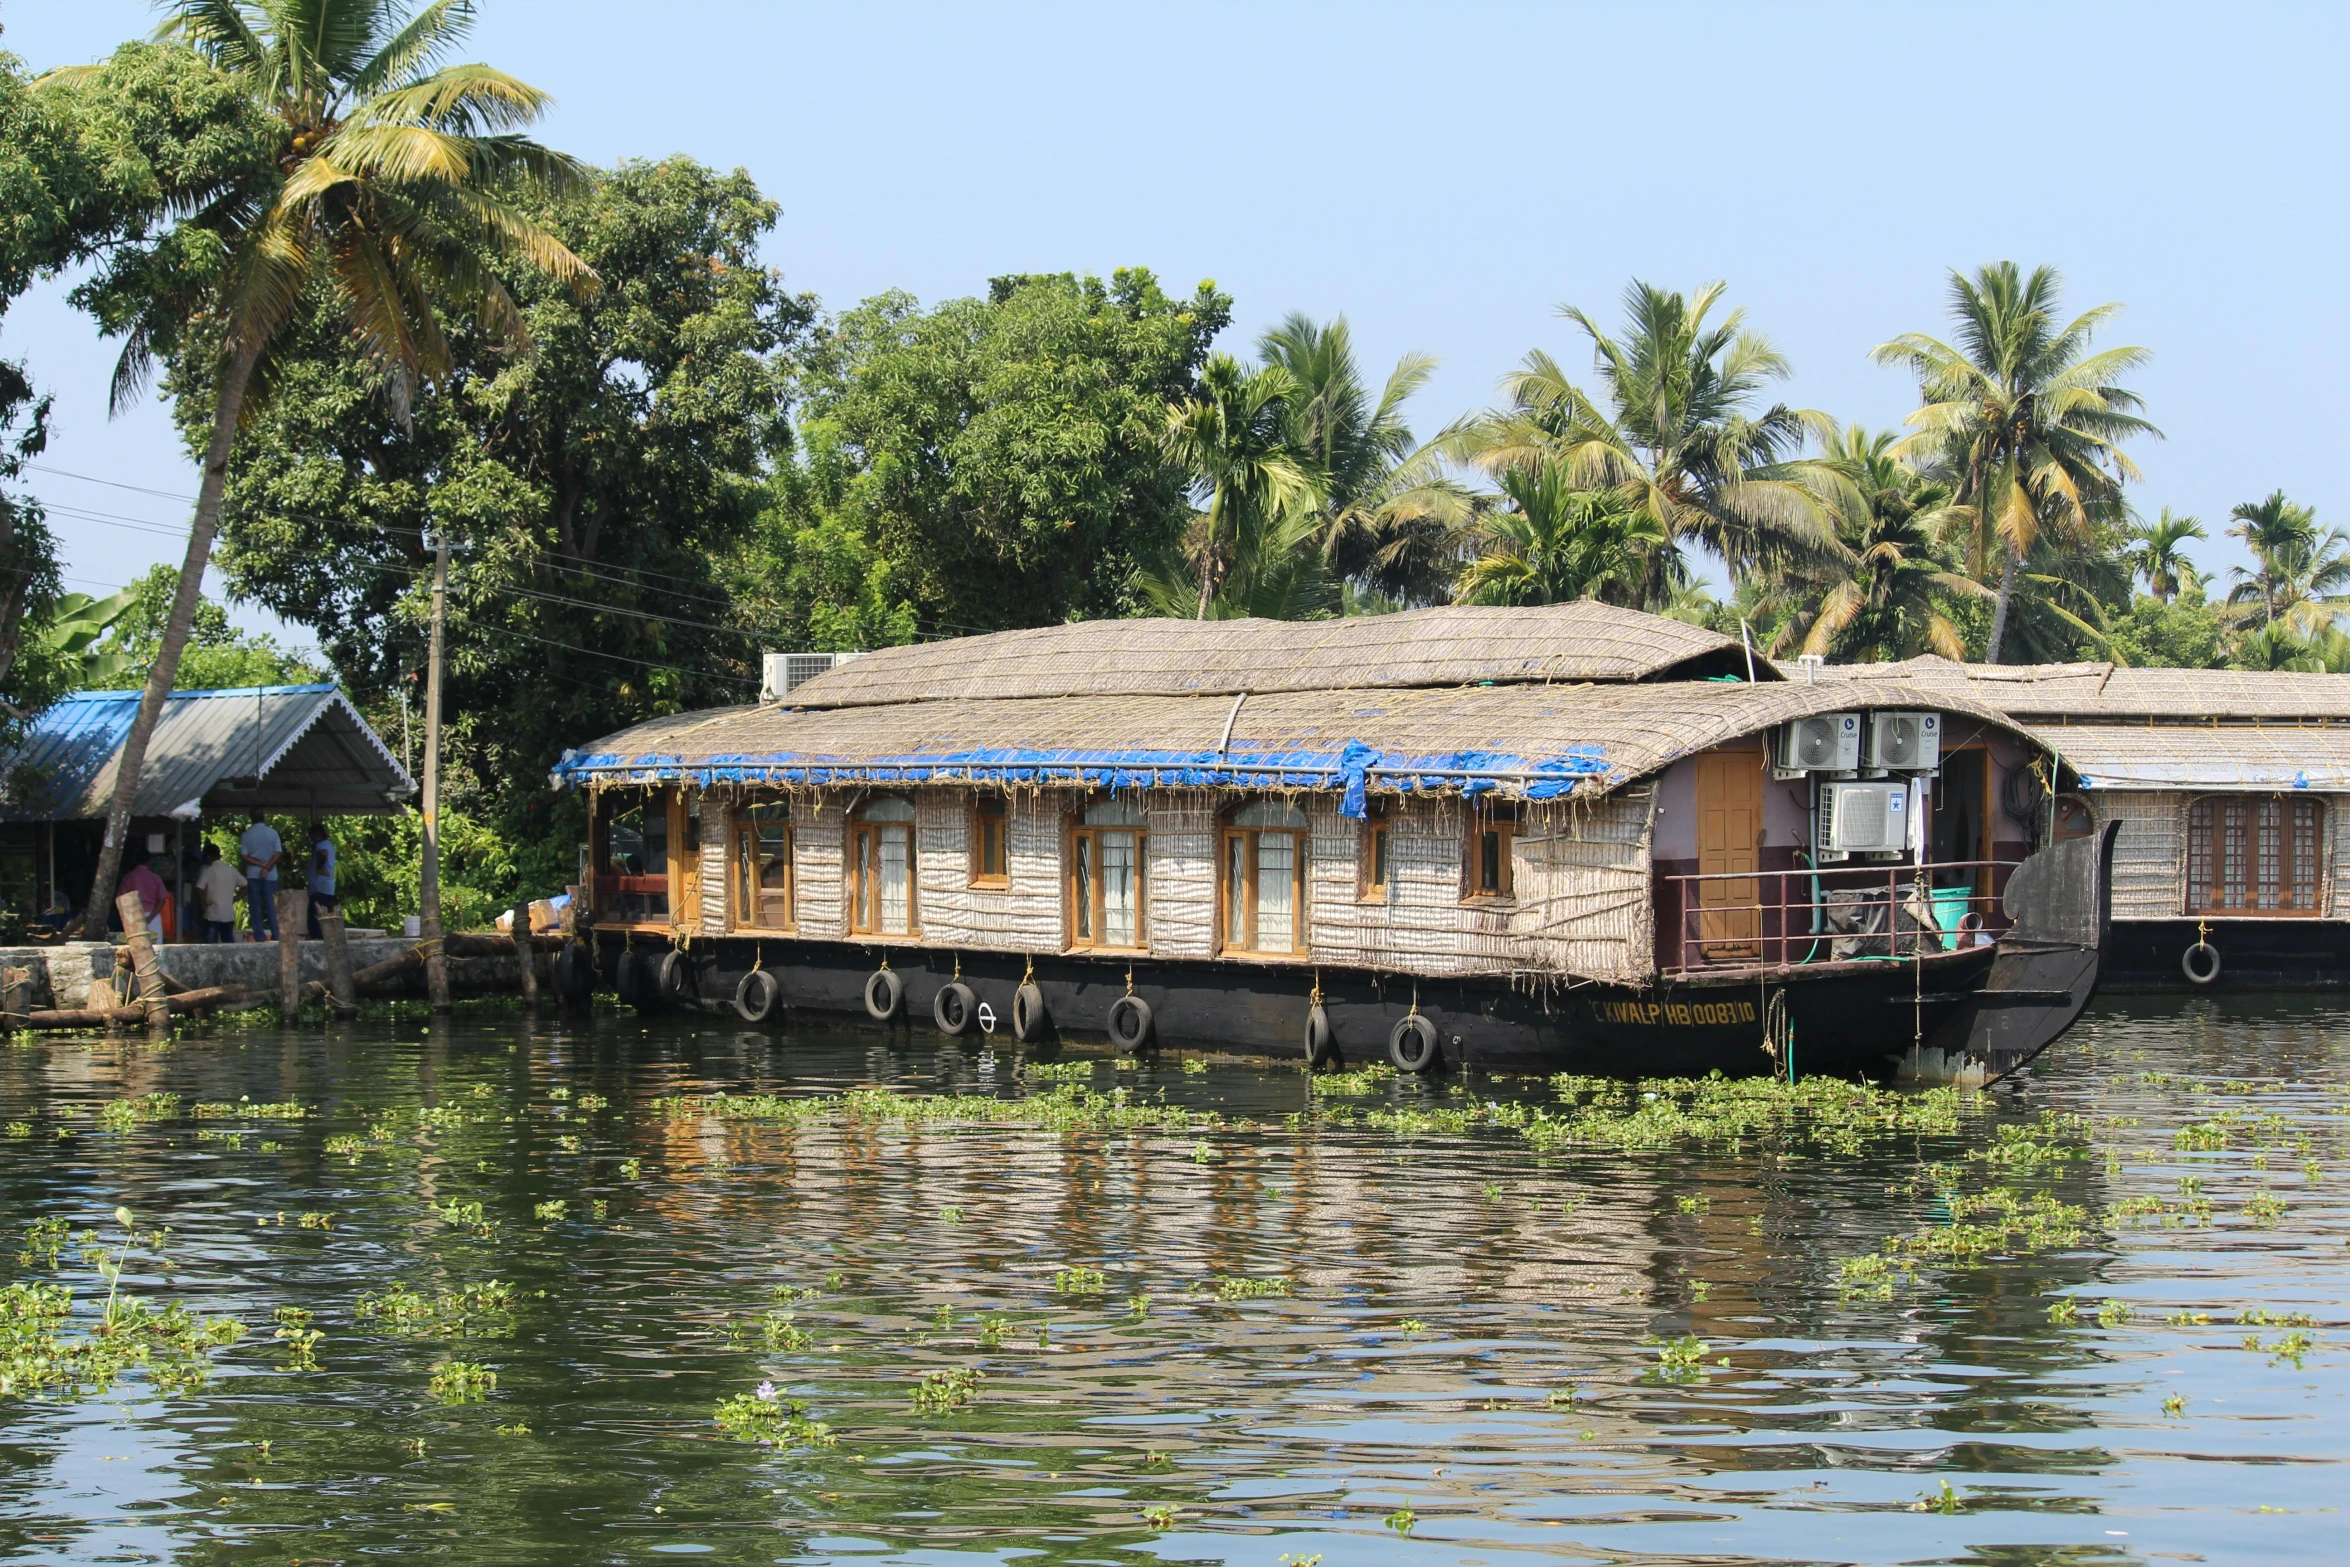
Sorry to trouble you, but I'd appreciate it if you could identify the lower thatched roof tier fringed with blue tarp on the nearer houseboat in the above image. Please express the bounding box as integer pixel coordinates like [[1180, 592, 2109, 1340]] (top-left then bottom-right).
[[555, 681, 2009, 799]]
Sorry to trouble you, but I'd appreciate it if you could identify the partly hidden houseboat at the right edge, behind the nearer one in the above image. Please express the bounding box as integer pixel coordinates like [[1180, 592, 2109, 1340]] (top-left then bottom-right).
[[1781, 658, 2350, 989]]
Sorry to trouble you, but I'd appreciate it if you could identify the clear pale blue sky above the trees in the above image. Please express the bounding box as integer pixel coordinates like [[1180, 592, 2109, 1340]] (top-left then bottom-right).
[[0, 0, 2350, 643]]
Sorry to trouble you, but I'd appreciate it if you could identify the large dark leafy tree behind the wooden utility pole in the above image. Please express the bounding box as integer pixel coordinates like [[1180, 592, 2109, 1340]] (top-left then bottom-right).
[[204, 157, 789, 893]]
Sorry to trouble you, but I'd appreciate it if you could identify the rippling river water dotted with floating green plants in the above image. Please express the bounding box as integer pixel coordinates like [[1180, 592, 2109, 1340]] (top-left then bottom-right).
[[0, 998, 2350, 1567]]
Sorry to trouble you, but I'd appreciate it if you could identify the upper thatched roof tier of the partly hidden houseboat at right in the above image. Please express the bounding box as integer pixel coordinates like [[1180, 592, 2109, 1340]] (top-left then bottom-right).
[[1779, 653, 2350, 724]]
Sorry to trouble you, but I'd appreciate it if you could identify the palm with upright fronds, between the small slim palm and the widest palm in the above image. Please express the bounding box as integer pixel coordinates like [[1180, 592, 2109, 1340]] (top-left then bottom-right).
[[1257, 312, 1469, 601]]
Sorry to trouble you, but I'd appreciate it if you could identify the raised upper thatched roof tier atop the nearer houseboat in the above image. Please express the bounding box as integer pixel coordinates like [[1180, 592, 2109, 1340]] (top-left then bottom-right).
[[790, 604, 1774, 707]]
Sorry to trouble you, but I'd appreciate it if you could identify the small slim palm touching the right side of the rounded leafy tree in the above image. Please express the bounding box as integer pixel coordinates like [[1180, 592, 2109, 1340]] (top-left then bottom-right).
[[1161, 355, 1321, 620]]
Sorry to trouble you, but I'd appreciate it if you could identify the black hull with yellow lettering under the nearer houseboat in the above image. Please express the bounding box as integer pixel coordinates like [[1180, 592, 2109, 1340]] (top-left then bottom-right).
[[599, 933, 1995, 1076]]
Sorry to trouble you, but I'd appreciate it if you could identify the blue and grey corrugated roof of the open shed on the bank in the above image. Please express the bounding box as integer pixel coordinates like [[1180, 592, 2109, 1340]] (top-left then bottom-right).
[[0, 686, 416, 822]]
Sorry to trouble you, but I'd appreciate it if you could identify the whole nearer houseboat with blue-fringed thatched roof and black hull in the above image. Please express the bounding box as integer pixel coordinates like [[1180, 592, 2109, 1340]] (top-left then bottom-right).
[[552, 604, 2110, 1076]]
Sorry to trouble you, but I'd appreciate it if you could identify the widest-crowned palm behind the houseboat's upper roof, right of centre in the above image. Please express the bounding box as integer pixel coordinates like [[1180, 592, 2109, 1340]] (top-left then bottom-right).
[[1443, 280, 1842, 578]]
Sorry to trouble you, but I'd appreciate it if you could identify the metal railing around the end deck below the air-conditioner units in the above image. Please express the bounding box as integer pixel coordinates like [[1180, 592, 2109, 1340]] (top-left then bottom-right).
[[1657, 860, 2019, 973]]
